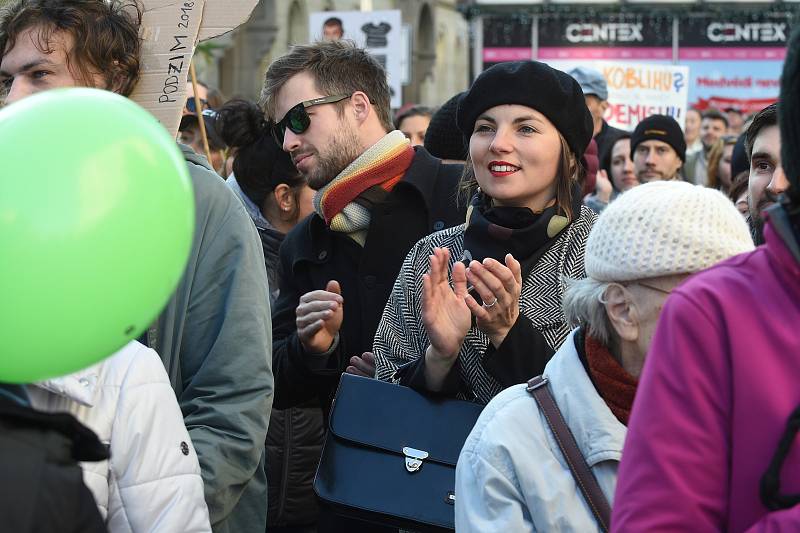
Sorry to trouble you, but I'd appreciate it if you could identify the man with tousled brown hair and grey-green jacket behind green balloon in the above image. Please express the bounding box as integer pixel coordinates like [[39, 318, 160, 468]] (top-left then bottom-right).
[[0, 0, 272, 532]]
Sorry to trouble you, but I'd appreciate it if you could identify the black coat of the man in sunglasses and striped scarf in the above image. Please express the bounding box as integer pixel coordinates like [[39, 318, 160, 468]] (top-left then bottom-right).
[[272, 147, 466, 413]]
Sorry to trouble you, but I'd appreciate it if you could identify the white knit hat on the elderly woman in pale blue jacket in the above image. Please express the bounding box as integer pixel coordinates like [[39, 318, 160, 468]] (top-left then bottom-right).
[[585, 181, 753, 282]]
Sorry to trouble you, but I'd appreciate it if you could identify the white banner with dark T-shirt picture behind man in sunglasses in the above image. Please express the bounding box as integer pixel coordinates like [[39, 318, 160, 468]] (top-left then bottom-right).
[[308, 9, 408, 108]]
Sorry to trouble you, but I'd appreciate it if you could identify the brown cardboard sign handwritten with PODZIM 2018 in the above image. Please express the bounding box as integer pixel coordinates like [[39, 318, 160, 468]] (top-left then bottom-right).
[[131, 0, 258, 136]]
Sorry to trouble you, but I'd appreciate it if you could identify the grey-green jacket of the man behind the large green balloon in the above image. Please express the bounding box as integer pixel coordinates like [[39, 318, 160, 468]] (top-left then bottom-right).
[[143, 146, 272, 533]]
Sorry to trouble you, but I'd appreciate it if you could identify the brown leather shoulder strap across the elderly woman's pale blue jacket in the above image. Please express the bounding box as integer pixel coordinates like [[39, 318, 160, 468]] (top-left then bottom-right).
[[526, 376, 611, 532]]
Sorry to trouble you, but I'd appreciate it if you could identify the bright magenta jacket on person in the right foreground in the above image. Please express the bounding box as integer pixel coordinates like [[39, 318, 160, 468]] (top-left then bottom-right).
[[612, 221, 800, 533]]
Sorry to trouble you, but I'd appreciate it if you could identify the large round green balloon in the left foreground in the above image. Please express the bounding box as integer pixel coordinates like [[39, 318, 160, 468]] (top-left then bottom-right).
[[0, 89, 194, 383]]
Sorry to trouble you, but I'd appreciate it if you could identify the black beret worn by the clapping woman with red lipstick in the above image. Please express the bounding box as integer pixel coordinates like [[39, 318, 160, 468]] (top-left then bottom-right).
[[457, 61, 594, 159]]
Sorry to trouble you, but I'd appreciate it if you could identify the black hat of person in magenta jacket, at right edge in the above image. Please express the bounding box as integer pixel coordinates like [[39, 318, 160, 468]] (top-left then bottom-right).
[[778, 28, 800, 206]]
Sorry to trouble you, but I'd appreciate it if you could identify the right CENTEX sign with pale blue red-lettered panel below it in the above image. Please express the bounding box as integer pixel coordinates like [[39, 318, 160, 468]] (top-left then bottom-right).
[[678, 13, 791, 113]]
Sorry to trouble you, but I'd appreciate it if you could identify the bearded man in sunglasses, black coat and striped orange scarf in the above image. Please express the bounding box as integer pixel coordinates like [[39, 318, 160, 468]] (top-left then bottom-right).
[[262, 41, 465, 420]]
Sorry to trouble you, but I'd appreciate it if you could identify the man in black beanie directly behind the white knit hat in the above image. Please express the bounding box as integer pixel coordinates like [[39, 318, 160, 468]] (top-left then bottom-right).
[[631, 115, 686, 183]]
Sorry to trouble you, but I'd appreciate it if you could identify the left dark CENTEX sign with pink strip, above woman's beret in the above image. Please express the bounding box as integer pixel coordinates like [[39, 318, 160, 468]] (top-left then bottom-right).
[[538, 16, 673, 62]]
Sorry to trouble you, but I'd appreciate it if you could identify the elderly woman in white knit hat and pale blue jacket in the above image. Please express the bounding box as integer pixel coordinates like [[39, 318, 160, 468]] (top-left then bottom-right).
[[455, 182, 753, 533]]
